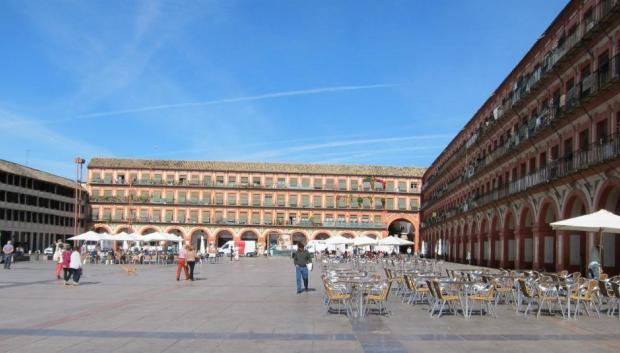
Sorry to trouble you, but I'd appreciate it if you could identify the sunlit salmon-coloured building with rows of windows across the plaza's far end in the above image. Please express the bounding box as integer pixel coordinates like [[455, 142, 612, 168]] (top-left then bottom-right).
[[88, 158, 424, 252]]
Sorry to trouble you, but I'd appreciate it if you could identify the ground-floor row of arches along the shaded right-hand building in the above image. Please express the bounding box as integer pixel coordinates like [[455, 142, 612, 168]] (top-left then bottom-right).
[[423, 178, 620, 274]]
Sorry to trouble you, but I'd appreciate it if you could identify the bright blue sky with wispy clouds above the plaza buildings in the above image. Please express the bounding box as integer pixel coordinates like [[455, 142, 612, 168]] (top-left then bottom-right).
[[0, 0, 567, 177]]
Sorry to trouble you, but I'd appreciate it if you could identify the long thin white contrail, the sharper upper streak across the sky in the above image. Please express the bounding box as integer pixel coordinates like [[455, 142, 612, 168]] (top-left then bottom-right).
[[78, 83, 403, 118]]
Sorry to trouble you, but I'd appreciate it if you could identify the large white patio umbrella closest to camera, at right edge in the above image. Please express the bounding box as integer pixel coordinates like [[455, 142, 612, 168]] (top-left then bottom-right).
[[549, 210, 620, 268]]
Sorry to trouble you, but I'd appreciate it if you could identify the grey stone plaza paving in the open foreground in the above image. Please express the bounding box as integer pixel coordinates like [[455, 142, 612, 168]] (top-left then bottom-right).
[[0, 258, 620, 353]]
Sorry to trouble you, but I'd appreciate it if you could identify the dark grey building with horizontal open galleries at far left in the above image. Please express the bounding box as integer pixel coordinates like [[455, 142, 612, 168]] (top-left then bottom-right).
[[0, 160, 88, 252]]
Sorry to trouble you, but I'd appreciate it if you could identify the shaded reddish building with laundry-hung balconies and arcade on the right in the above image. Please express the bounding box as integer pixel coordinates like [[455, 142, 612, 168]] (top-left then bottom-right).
[[422, 0, 620, 273]]
